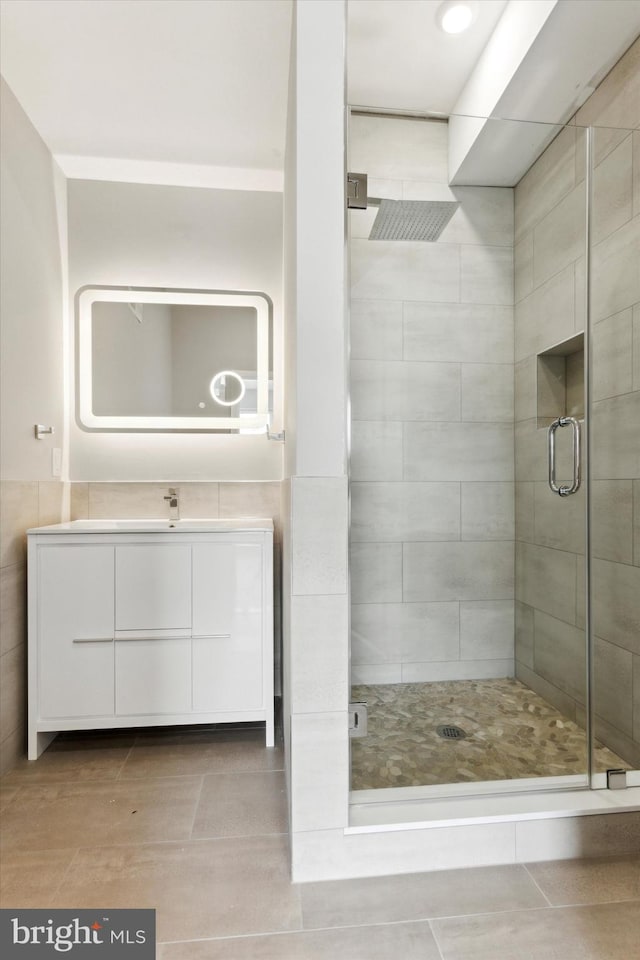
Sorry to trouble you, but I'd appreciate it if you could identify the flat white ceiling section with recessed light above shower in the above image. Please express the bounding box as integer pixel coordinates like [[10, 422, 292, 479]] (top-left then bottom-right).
[[347, 0, 507, 116]]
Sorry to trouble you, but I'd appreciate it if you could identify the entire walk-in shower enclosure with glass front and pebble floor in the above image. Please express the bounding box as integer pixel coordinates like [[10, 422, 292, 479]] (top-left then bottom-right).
[[348, 110, 640, 800]]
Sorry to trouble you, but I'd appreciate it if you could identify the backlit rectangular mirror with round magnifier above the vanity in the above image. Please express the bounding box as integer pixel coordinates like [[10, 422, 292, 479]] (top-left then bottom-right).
[[76, 287, 271, 433]]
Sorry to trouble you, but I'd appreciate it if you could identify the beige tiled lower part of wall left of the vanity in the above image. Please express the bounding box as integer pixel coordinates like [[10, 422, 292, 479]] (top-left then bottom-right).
[[0, 480, 68, 775]]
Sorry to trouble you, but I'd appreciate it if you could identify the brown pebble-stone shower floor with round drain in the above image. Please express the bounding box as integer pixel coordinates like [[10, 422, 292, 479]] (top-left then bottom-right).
[[351, 677, 628, 790]]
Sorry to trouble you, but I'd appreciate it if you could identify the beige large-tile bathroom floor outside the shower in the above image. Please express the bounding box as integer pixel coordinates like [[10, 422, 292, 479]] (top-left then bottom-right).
[[0, 730, 640, 960]]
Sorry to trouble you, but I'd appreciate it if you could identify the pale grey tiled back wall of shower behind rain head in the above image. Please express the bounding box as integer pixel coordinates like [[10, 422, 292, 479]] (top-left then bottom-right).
[[349, 116, 514, 683]]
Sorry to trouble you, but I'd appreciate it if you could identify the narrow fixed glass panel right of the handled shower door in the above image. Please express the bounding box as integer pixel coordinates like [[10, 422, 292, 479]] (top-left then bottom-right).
[[589, 127, 640, 786]]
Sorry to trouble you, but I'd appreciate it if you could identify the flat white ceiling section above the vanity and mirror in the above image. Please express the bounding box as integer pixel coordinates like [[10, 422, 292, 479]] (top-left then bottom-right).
[[1, 0, 292, 189]]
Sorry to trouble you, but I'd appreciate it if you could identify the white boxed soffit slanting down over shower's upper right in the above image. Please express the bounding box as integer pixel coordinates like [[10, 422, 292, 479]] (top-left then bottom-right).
[[449, 0, 640, 186]]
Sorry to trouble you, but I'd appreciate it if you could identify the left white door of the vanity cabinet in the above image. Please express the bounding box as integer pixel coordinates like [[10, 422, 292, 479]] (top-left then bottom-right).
[[37, 544, 114, 719]]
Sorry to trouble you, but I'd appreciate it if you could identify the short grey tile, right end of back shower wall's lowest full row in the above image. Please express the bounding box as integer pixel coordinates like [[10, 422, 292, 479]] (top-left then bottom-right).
[[460, 600, 514, 660]]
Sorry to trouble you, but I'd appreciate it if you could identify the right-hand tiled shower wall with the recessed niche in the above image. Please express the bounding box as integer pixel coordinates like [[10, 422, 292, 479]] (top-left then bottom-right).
[[515, 42, 640, 766]]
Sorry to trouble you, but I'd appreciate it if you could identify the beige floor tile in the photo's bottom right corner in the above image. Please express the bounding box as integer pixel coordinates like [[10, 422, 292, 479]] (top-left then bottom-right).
[[432, 900, 640, 960]]
